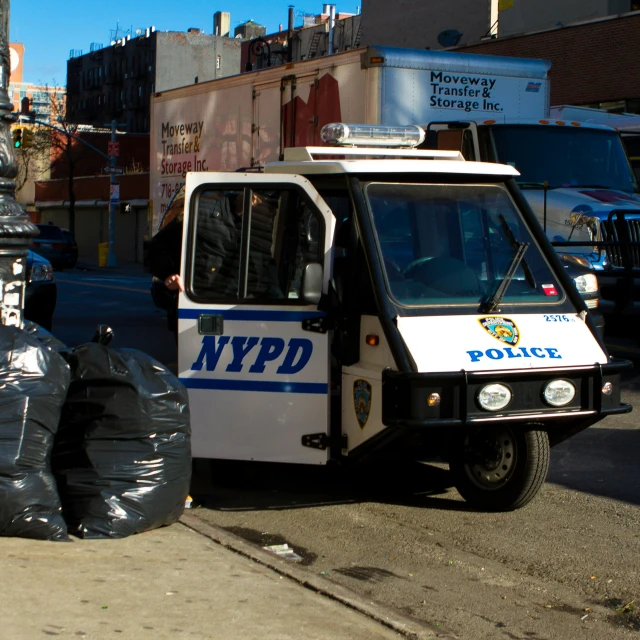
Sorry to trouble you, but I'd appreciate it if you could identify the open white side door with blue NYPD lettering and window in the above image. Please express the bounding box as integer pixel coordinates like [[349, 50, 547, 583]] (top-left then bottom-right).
[[178, 173, 334, 464]]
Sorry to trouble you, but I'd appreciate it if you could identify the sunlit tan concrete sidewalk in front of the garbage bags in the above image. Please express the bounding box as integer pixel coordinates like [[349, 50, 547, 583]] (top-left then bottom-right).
[[0, 523, 440, 640]]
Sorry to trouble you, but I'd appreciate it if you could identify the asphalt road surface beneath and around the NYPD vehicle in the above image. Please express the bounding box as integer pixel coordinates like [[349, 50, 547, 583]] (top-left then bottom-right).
[[54, 271, 640, 640]]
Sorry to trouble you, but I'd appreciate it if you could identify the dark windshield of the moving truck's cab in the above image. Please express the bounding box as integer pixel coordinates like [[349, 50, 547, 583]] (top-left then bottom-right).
[[490, 125, 637, 193]]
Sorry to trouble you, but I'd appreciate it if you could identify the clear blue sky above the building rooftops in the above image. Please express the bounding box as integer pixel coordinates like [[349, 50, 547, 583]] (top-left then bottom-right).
[[9, 0, 362, 86]]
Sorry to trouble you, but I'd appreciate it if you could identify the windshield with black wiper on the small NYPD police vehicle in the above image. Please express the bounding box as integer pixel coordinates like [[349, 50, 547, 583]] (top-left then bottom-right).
[[365, 182, 562, 312]]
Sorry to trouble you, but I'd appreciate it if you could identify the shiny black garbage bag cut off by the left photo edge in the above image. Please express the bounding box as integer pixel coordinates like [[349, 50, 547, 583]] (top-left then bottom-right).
[[0, 325, 69, 540]]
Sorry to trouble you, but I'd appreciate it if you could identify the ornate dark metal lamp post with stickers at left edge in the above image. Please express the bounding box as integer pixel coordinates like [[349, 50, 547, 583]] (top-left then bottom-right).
[[0, 0, 38, 326]]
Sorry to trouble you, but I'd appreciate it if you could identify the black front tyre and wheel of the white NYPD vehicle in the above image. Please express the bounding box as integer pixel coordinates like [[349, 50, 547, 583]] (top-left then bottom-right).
[[449, 425, 550, 511]]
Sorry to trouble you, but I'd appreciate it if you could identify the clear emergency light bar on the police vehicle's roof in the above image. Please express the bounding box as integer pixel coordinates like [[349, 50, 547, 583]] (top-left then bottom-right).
[[320, 122, 425, 147]]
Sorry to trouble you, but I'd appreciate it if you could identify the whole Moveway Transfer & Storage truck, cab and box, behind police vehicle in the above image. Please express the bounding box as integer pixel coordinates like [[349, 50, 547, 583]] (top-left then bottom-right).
[[151, 47, 640, 311]]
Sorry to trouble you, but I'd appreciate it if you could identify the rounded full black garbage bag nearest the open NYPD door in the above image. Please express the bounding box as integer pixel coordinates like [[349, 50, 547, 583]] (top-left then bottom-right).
[[53, 343, 191, 538]]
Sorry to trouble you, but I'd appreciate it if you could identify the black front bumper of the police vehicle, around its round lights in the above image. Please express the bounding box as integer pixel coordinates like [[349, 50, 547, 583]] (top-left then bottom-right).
[[382, 359, 633, 429]]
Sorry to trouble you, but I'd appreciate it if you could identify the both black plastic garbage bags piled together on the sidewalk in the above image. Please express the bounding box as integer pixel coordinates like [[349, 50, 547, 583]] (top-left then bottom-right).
[[0, 322, 191, 540]]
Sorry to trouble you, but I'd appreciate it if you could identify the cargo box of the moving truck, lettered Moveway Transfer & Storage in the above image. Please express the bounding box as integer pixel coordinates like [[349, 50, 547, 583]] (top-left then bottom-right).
[[151, 47, 550, 228]]
